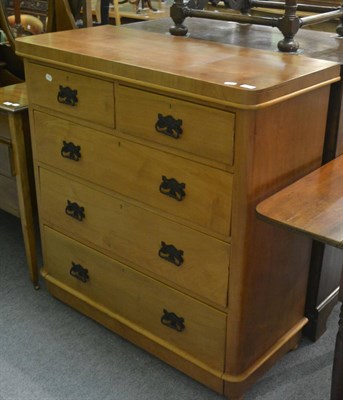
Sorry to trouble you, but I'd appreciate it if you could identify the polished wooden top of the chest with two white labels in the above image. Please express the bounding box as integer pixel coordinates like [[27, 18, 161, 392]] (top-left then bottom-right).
[[17, 25, 339, 108]]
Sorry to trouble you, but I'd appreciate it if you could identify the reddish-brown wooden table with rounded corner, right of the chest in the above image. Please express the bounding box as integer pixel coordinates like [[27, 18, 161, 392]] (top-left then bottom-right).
[[256, 156, 343, 400]]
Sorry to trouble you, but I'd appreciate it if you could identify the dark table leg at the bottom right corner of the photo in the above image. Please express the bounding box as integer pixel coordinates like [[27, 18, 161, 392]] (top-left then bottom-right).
[[331, 303, 343, 400]]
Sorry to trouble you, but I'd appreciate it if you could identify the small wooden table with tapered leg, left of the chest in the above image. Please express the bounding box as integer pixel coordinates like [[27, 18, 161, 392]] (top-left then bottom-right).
[[0, 83, 39, 289]]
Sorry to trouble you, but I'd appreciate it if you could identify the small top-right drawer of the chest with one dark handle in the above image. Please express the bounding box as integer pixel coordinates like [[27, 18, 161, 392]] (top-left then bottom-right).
[[116, 85, 235, 165]]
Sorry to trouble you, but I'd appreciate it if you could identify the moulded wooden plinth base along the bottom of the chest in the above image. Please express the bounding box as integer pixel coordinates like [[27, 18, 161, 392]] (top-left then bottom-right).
[[41, 268, 308, 394]]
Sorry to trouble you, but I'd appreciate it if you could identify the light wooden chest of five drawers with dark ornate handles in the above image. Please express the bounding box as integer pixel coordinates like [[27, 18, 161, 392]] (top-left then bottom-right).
[[17, 26, 339, 399]]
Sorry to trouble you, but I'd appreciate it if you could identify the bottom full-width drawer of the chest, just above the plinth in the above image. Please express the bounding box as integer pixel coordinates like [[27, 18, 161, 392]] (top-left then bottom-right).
[[44, 227, 226, 371]]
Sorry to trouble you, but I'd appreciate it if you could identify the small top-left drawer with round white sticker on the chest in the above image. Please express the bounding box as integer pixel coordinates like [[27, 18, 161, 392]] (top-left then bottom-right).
[[26, 63, 115, 128]]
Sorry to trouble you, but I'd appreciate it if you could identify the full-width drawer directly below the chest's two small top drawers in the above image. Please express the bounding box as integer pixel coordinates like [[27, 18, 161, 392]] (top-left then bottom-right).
[[34, 112, 232, 237]]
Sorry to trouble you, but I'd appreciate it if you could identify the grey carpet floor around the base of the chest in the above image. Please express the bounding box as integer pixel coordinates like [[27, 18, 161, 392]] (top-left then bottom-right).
[[0, 210, 343, 400]]
